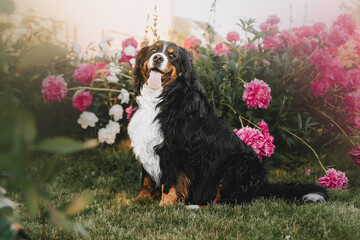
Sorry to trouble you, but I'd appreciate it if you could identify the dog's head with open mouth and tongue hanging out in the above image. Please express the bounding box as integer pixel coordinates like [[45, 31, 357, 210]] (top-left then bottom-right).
[[134, 41, 193, 93]]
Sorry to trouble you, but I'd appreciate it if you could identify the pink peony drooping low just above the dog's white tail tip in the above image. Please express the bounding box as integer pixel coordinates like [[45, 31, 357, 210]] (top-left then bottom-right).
[[318, 168, 349, 189]]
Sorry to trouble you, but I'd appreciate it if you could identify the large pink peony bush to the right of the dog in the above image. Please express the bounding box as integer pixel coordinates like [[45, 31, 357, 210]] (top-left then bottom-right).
[[190, 15, 360, 189]]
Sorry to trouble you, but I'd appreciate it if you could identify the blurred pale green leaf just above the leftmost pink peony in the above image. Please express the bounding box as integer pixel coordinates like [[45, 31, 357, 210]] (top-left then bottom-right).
[[18, 44, 66, 71]]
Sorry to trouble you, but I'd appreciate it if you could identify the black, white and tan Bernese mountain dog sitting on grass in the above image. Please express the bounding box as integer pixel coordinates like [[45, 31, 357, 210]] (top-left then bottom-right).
[[128, 41, 328, 206]]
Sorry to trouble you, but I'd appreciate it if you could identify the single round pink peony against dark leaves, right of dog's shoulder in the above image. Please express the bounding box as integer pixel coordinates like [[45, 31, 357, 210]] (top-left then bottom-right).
[[242, 78, 271, 109]]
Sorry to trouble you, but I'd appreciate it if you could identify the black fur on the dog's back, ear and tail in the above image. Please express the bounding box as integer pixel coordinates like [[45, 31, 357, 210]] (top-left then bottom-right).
[[135, 42, 327, 205]]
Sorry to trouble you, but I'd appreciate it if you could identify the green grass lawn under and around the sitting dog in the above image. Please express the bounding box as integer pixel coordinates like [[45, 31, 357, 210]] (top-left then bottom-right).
[[12, 149, 360, 239]]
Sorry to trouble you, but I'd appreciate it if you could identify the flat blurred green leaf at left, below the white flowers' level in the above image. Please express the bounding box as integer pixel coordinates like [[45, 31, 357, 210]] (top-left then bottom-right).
[[35, 137, 84, 154]]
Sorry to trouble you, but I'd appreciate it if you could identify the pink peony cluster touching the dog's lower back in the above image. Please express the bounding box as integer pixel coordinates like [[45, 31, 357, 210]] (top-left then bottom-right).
[[234, 121, 275, 160]]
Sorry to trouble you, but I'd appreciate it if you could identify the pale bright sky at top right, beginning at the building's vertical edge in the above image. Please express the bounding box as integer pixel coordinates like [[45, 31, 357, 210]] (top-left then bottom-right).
[[174, 0, 350, 36]]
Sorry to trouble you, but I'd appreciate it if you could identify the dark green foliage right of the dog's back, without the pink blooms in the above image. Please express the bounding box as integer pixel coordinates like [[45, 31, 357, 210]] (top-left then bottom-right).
[[194, 19, 352, 168]]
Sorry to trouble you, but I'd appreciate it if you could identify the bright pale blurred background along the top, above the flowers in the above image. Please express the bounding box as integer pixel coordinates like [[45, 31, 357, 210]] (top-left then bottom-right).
[[1, 0, 356, 49]]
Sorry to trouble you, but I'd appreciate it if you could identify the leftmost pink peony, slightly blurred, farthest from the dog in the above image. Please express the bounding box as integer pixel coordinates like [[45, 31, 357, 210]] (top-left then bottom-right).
[[41, 76, 67, 103]]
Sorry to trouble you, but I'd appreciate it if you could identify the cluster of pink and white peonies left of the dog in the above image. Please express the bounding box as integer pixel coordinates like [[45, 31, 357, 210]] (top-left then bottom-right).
[[42, 37, 137, 145]]
